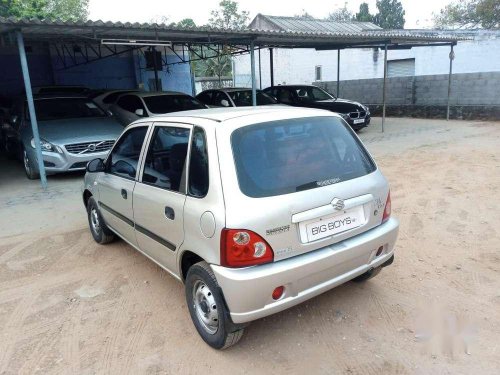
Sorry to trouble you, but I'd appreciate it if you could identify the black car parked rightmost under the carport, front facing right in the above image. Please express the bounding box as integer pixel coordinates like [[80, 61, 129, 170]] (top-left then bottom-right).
[[264, 85, 370, 130]]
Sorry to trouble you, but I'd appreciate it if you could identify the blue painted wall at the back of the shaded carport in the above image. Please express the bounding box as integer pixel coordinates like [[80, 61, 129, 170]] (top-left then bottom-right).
[[0, 43, 192, 95]]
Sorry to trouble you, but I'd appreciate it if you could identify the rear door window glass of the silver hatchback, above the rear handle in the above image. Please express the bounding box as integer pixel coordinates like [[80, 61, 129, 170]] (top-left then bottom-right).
[[142, 126, 189, 193]]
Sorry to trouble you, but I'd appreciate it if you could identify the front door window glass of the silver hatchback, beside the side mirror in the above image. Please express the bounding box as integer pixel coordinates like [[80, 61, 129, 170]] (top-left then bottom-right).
[[106, 126, 148, 179]]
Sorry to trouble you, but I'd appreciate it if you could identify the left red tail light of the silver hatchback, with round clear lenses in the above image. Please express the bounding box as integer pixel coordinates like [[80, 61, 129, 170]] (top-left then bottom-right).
[[220, 229, 274, 267]]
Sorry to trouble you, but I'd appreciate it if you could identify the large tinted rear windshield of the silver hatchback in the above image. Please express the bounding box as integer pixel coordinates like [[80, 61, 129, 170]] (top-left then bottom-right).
[[231, 117, 376, 198]]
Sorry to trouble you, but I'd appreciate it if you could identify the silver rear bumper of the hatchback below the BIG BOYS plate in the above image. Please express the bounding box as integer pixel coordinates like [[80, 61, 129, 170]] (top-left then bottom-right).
[[212, 218, 399, 323]]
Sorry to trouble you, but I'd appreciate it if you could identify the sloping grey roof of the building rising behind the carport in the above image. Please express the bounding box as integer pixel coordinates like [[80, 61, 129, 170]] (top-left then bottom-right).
[[256, 14, 382, 33]]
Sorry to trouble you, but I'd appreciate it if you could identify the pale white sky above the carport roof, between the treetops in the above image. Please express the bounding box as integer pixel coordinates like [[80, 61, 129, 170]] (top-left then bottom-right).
[[89, 0, 452, 29]]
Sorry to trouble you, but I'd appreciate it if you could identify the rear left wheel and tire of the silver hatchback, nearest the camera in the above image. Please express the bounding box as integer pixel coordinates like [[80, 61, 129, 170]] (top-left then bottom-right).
[[185, 262, 244, 350]]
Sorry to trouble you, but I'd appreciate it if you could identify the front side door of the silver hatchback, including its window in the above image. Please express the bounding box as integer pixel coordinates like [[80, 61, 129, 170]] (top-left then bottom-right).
[[98, 126, 148, 245]]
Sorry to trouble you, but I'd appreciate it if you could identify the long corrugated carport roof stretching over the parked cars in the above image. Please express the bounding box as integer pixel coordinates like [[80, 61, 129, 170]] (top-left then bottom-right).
[[0, 17, 467, 49]]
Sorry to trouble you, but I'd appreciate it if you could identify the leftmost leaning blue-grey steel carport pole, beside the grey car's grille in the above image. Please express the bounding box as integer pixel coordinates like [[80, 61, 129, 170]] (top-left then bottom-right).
[[16, 31, 47, 189]]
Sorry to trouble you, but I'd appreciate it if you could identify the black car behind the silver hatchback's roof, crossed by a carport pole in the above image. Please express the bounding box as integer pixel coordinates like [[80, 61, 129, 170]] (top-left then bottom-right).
[[196, 87, 278, 107]]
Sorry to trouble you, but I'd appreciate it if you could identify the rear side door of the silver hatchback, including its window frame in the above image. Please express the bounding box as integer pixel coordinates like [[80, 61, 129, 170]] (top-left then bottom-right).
[[134, 123, 191, 272]]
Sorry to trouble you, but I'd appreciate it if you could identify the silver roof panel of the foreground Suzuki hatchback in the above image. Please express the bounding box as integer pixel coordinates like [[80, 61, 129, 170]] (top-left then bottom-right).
[[133, 106, 340, 123]]
